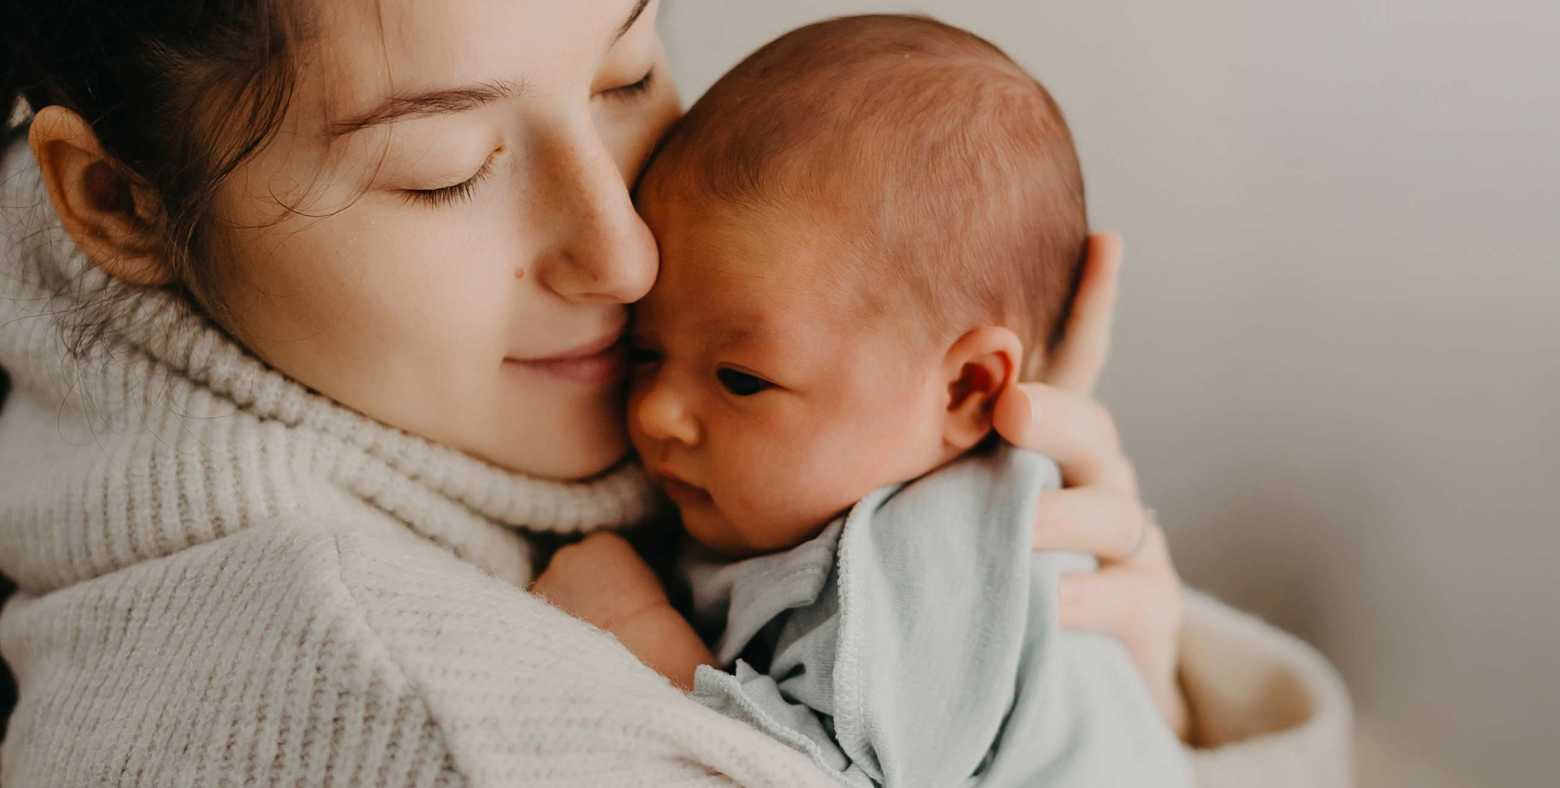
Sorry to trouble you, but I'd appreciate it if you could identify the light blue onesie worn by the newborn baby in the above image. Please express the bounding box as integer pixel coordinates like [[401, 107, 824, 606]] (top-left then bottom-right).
[[683, 446, 1192, 788]]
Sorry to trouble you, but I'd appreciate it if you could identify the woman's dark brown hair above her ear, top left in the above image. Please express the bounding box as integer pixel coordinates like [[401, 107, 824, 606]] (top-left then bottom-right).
[[0, 0, 303, 332]]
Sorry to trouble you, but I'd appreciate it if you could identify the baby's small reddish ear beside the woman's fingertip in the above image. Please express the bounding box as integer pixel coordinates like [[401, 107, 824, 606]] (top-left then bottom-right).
[[942, 326, 1023, 451]]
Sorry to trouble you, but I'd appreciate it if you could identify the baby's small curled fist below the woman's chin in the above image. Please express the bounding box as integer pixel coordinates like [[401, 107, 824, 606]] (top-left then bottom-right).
[[530, 531, 671, 632]]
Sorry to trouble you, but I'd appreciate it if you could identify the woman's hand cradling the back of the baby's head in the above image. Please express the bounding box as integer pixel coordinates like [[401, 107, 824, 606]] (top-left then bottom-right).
[[994, 232, 1190, 738]]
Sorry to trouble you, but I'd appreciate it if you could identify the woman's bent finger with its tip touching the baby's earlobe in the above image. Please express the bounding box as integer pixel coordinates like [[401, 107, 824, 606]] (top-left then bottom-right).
[[992, 384, 1137, 498]]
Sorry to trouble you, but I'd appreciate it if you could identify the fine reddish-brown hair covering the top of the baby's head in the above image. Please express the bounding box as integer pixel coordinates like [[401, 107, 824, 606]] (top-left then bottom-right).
[[641, 16, 1089, 378]]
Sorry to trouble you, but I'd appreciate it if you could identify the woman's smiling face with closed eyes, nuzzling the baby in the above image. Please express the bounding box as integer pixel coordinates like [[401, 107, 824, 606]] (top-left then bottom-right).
[[209, 0, 680, 479]]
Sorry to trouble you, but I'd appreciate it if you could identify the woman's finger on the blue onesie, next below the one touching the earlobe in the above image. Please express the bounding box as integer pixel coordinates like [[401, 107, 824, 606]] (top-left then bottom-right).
[[1033, 487, 1148, 562]]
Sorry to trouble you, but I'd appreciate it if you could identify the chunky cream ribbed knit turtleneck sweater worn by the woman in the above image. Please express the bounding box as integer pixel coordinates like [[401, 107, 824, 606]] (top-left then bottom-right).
[[0, 142, 1348, 788]]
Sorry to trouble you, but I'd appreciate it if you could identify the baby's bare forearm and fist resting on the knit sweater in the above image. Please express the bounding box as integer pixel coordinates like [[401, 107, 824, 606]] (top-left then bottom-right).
[[530, 532, 714, 691]]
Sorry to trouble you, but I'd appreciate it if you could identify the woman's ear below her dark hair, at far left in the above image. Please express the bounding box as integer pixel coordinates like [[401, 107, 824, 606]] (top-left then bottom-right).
[[28, 106, 173, 286]]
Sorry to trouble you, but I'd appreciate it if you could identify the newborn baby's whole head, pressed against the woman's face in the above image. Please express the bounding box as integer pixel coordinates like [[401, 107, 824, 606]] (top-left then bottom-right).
[[629, 16, 1087, 554]]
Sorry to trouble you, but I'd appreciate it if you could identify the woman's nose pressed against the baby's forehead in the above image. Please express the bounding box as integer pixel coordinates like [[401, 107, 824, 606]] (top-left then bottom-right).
[[537, 128, 660, 304]]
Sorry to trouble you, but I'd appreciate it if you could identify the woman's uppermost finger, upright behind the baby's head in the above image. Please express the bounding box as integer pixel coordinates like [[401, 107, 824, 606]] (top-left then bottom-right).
[[1042, 232, 1126, 393]]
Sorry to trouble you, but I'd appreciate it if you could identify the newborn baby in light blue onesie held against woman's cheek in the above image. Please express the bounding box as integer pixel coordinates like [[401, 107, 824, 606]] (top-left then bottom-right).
[[542, 16, 1190, 786]]
